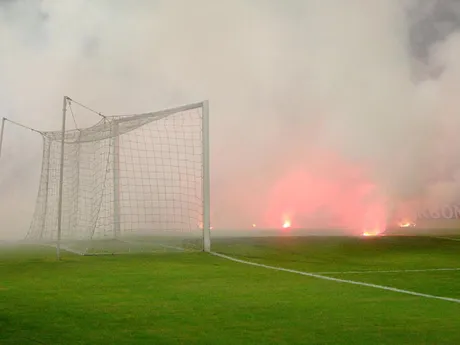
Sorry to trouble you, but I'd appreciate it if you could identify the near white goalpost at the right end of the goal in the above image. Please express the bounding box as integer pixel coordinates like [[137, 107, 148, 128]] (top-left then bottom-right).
[[202, 101, 211, 253]]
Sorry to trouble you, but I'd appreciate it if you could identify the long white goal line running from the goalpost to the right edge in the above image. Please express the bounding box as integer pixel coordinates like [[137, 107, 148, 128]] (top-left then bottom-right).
[[211, 252, 460, 304]]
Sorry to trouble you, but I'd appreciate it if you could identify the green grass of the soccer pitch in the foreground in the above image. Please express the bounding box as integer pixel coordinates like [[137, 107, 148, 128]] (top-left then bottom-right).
[[0, 237, 460, 345]]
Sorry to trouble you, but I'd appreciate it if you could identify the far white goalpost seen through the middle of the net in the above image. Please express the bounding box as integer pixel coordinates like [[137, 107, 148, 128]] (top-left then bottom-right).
[[112, 121, 120, 238]]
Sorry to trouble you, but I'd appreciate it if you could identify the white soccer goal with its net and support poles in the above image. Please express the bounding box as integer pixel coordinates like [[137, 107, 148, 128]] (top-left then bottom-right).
[[0, 97, 211, 256]]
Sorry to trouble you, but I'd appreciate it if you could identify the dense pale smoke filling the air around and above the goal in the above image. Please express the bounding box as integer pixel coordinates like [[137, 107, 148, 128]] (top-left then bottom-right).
[[0, 0, 460, 237]]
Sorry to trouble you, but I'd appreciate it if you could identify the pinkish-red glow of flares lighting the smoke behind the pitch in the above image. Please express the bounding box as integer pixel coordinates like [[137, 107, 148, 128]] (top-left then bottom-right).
[[265, 150, 386, 234]]
